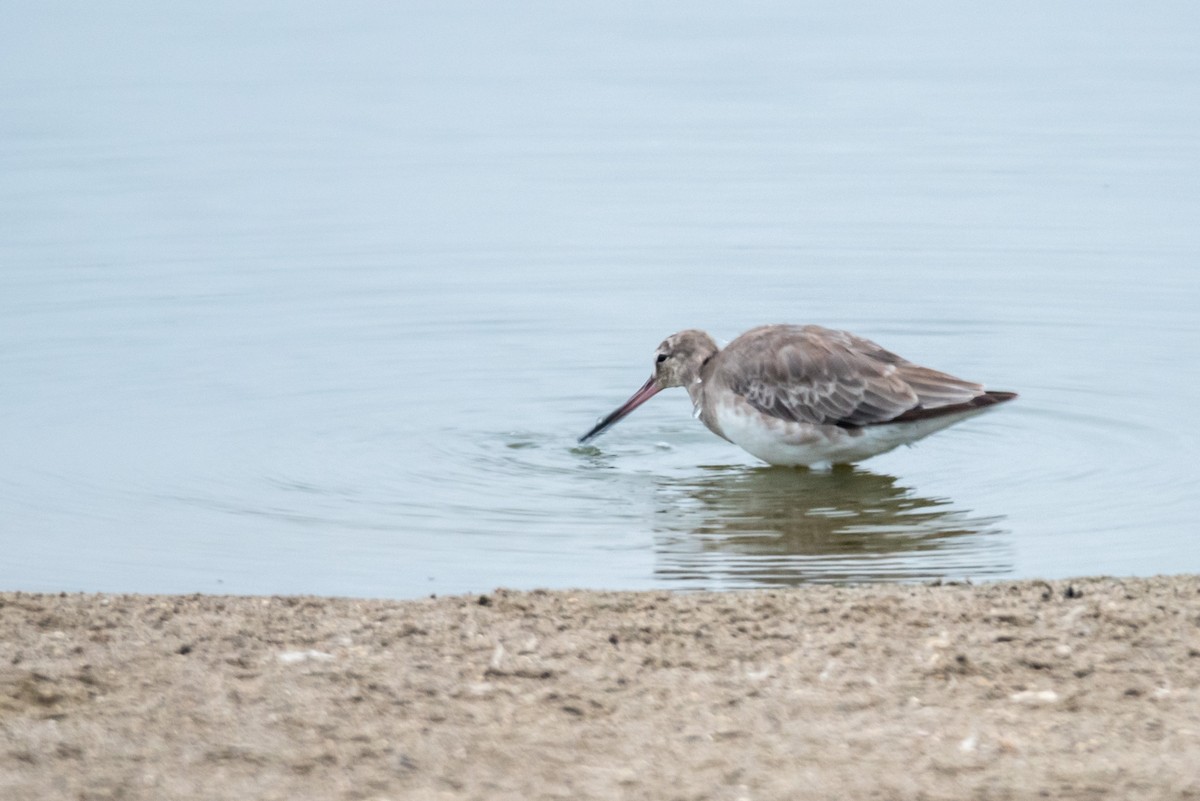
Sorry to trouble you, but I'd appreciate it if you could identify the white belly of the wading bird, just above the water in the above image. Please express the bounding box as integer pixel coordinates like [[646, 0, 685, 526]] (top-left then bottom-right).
[[716, 403, 980, 468]]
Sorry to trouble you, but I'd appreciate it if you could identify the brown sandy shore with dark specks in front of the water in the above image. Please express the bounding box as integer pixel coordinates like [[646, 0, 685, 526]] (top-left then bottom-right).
[[0, 576, 1200, 801]]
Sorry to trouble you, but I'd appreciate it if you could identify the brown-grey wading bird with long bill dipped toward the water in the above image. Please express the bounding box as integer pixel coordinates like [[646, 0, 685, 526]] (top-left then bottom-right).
[[580, 325, 1016, 469]]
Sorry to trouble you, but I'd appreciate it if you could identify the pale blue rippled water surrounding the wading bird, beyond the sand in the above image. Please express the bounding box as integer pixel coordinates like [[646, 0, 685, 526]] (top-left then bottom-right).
[[0, 2, 1200, 597]]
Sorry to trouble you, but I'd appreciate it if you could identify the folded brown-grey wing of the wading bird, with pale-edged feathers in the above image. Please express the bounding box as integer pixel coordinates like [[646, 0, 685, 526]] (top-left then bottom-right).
[[716, 326, 983, 427]]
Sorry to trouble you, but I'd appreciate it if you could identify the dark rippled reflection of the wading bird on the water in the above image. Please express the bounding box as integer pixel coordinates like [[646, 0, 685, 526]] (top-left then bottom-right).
[[655, 466, 1013, 589]]
